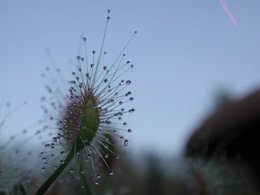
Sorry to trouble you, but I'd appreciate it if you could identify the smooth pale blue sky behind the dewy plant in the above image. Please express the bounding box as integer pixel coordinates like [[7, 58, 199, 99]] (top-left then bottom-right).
[[0, 0, 260, 158]]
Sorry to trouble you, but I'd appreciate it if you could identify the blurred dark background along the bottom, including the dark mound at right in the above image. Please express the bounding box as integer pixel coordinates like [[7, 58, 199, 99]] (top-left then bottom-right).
[[0, 90, 260, 195]]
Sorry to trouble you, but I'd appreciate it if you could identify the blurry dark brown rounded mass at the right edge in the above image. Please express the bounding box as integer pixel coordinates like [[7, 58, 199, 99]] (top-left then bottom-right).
[[185, 89, 260, 185]]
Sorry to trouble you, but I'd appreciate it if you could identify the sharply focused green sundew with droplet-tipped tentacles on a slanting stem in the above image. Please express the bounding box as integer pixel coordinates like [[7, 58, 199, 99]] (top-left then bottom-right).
[[36, 10, 137, 194]]
